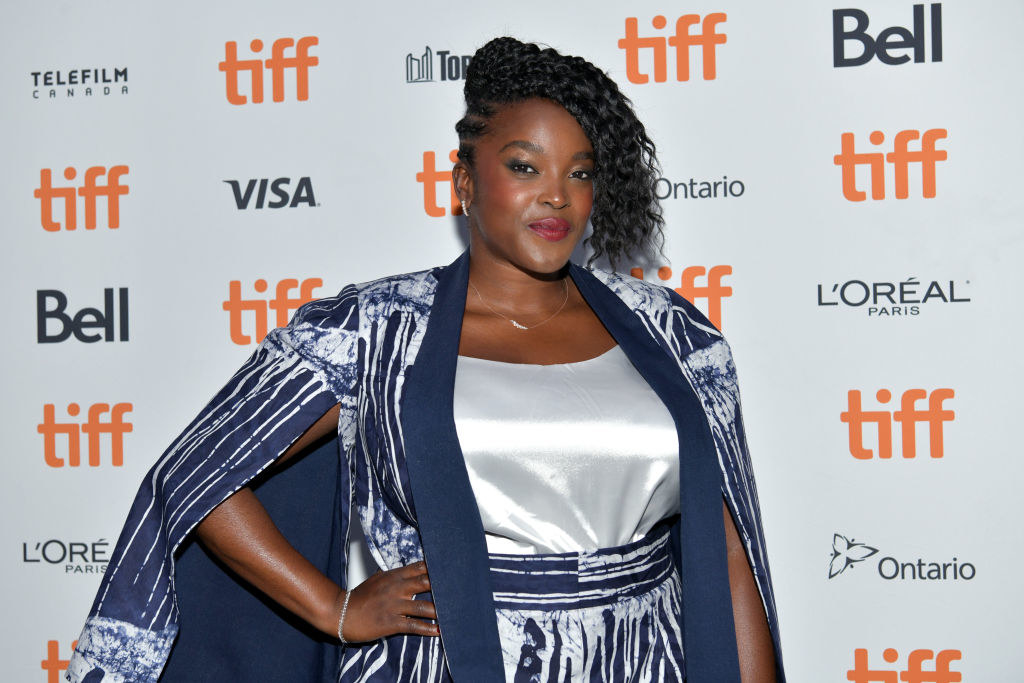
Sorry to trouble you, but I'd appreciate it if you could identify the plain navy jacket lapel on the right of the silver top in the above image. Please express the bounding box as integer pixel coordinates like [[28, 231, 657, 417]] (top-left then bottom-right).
[[569, 264, 739, 683]]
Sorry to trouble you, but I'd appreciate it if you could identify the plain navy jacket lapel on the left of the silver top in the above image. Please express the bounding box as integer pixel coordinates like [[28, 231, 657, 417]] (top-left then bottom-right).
[[400, 251, 505, 682]]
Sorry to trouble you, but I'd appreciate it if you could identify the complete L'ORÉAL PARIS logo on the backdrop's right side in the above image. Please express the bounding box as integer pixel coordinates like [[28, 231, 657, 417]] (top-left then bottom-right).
[[817, 276, 971, 317]]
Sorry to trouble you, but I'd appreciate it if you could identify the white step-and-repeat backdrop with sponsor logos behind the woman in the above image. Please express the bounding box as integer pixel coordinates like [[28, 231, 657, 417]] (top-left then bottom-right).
[[0, 0, 1024, 683]]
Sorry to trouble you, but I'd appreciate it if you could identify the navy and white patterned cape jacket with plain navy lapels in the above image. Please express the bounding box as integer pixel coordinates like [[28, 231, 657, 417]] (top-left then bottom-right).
[[67, 253, 782, 683]]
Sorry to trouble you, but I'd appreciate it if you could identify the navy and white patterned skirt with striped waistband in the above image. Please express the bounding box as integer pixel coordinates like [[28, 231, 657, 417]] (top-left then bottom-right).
[[338, 525, 685, 683]]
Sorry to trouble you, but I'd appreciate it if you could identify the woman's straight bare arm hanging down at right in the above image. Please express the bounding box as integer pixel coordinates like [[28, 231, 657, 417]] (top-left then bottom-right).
[[722, 501, 775, 683]]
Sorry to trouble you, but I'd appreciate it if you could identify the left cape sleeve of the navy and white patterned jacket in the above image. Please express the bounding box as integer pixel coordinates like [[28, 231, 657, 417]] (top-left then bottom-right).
[[66, 287, 358, 683]]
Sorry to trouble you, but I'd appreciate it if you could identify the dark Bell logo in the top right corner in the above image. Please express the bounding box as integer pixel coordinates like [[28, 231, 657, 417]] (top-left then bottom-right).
[[833, 2, 942, 69]]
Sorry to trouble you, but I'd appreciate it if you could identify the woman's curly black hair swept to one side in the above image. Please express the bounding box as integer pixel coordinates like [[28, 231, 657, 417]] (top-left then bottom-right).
[[455, 37, 665, 267]]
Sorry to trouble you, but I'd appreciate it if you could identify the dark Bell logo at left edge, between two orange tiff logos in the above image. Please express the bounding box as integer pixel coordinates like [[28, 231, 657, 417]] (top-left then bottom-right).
[[36, 287, 128, 344]]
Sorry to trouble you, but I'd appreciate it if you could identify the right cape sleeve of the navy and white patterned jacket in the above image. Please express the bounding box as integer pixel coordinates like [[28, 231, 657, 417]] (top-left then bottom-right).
[[669, 292, 784, 681]]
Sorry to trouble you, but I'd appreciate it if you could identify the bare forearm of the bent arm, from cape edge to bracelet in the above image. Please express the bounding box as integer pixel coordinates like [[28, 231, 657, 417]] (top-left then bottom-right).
[[197, 487, 341, 635]]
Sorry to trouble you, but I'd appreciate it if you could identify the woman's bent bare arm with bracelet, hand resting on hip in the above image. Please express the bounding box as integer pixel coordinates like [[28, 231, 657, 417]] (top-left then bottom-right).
[[197, 405, 437, 641]]
